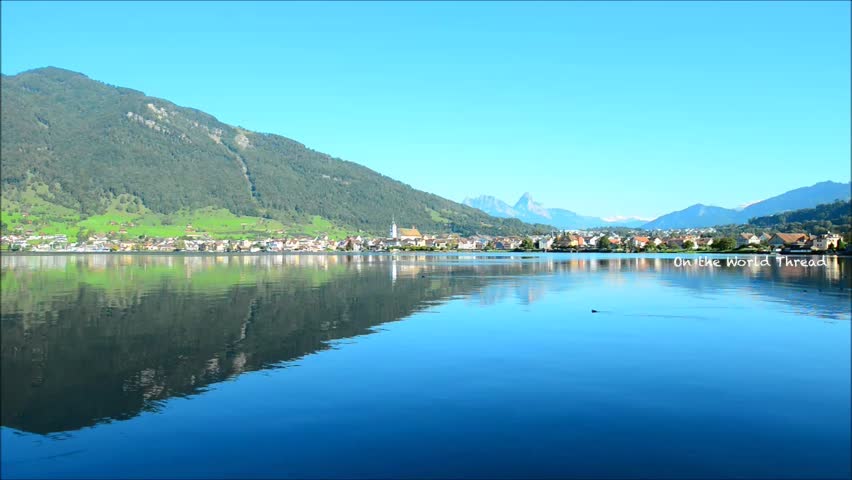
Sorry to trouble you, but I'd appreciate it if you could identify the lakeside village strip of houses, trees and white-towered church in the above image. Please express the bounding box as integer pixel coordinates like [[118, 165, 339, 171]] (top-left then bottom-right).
[[0, 218, 850, 253]]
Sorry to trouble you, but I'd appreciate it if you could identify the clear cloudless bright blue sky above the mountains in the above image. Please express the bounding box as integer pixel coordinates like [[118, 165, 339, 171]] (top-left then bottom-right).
[[0, 1, 851, 217]]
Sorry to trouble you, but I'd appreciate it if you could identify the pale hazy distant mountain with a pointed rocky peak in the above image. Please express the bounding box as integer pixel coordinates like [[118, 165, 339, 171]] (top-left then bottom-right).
[[463, 192, 645, 230]]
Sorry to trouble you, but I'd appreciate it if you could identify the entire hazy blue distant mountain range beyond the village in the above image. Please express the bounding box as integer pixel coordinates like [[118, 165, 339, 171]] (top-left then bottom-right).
[[463, 181, 850, 230]]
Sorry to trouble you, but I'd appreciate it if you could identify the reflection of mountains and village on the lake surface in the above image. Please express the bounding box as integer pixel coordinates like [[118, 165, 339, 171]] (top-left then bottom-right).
[[0, 255, 850, 433]]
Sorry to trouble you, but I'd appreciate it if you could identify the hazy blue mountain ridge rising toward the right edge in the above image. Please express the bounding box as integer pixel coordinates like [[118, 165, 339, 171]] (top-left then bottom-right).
[[642, 182, 850, 230]]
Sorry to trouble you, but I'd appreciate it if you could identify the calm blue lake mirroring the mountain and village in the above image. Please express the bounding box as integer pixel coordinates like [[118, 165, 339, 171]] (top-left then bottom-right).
[[0, 254, 852, 478]]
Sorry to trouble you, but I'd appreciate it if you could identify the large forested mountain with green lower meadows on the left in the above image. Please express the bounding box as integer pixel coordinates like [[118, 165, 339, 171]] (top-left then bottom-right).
[[0, 67, 549, 238]]
